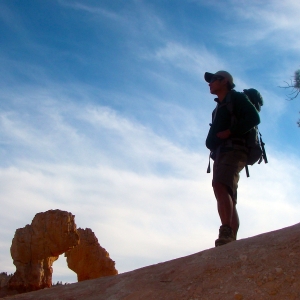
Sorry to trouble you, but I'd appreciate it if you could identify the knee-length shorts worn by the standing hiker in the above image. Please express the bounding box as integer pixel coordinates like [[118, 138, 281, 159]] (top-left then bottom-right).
[[213, 150, 247, 203]]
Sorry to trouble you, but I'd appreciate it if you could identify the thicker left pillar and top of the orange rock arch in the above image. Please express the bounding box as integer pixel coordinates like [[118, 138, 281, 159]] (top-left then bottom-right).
[[8, 210, 79, 292]]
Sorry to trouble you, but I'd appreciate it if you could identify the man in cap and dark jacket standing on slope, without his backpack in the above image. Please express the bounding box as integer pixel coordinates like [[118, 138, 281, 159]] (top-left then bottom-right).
[[204, 71, 260, 247]]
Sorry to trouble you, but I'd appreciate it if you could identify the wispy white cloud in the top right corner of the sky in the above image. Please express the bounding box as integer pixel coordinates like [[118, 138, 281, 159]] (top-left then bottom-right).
[[211, 0, 300, 50]]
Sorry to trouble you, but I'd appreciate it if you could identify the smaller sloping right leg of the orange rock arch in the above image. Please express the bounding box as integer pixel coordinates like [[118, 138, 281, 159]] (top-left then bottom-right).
[[65, 228, 118, 281]]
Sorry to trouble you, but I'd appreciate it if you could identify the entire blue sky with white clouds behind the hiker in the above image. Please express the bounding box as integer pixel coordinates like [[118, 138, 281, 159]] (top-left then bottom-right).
[[0, 0, 300, 282]]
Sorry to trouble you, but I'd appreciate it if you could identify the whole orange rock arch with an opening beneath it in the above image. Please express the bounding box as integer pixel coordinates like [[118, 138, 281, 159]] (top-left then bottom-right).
[[8, 209, 118, 292]]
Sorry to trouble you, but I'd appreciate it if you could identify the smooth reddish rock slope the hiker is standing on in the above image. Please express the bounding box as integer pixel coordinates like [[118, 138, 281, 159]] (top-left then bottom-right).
[[8, 224, 300, 300]]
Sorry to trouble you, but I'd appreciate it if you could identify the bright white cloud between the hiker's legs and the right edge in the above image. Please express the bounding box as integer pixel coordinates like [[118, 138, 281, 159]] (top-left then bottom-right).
[[238, 149, 300, 238]]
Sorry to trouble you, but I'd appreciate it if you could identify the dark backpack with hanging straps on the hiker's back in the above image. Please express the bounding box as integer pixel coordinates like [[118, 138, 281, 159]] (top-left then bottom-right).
[[227, 88, 268, 177]]
